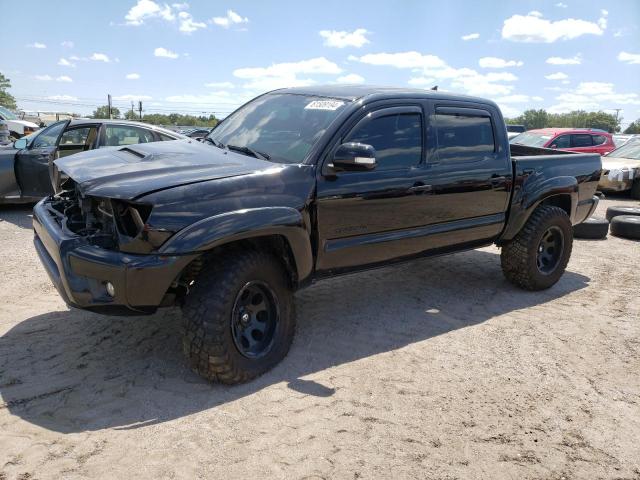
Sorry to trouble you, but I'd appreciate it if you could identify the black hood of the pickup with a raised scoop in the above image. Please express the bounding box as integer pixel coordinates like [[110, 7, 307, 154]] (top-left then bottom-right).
[[55, 140, 274, 200]]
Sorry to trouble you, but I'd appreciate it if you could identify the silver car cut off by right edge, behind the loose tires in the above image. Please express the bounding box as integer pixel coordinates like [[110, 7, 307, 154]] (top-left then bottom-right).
[[598, 138, 640, 200]]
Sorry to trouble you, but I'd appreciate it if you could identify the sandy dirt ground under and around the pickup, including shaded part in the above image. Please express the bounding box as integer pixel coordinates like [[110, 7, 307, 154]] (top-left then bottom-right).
[[0, 197, 640, 480]]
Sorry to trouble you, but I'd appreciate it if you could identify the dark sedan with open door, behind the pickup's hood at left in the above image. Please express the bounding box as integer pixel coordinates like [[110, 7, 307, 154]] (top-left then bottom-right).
[[0, 119, 185, 203]]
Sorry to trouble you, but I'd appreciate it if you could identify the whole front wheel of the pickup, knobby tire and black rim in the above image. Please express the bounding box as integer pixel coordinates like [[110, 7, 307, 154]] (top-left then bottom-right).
[[183, 250, 295, 384]]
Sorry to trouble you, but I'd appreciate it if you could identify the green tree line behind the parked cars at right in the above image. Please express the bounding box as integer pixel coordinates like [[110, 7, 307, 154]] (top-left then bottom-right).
[[505, 109, 640, 133]]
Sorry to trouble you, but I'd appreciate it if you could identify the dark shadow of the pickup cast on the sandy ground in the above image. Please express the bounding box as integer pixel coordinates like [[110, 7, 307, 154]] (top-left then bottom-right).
[[0, 250, 589, 433]]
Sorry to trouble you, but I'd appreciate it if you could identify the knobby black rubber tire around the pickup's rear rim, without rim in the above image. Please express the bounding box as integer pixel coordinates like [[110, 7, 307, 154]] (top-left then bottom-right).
[[500, 205, 573, 290]]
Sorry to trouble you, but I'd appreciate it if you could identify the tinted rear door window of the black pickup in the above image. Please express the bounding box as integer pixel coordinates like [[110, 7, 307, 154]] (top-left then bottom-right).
[[435, 109, 495, 161]]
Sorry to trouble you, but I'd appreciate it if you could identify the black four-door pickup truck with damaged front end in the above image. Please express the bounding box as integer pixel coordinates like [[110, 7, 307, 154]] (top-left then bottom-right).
[[33, 86, 601, 383]]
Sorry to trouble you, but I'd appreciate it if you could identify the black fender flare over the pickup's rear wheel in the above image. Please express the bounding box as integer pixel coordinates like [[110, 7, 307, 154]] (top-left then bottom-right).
[[497, 176, 578, 244]]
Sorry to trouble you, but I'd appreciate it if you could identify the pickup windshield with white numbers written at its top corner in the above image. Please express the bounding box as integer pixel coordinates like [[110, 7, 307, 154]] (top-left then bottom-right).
[[207, 93, 347, 163]]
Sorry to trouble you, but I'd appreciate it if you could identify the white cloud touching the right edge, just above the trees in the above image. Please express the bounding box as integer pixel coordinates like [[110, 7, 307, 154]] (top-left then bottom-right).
[[548, 82, 640, 113]]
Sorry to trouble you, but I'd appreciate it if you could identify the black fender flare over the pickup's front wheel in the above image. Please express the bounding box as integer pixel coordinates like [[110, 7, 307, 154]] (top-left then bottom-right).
[[158, 207, 313, 281]]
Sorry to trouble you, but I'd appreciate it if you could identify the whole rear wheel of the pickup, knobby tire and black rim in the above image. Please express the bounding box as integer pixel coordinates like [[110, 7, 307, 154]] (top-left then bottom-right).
[[500, 205, 573, 290]]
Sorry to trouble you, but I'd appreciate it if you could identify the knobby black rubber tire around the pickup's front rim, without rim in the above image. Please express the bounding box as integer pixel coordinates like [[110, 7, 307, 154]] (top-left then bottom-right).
[[183, 250, 295, 384]]
